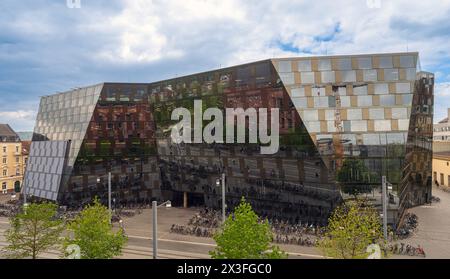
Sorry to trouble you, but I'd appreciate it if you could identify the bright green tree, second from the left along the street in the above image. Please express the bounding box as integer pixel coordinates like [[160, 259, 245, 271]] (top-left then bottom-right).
[[63, 199, 127, 259]]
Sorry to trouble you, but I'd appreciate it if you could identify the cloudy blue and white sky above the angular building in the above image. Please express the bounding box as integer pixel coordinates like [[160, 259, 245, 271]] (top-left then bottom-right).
[[0, 0, 450, 131]]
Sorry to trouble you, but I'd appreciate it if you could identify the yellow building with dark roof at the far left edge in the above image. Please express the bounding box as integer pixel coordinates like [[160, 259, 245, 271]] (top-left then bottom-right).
[[0, 124, 27, 194]]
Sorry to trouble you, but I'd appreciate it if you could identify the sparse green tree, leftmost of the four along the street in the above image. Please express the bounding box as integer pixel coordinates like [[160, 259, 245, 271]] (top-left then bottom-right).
[[3, 203, 64, 259]]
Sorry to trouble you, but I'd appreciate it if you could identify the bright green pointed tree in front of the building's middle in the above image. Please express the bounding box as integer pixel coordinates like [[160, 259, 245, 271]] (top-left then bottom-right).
[[210, 198, 287, 259]]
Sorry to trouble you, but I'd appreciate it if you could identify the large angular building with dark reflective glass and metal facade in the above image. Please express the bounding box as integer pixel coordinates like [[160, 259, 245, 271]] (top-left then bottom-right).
[[25, 53, 434, 228]]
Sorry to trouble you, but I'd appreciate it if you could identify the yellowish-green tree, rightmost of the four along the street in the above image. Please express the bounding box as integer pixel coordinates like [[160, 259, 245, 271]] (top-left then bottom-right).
[[318, 200, 385, 259]]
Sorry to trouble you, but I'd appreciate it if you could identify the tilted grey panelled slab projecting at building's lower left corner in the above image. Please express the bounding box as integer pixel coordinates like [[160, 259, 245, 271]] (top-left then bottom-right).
[[24, 141, 70, 201]]
